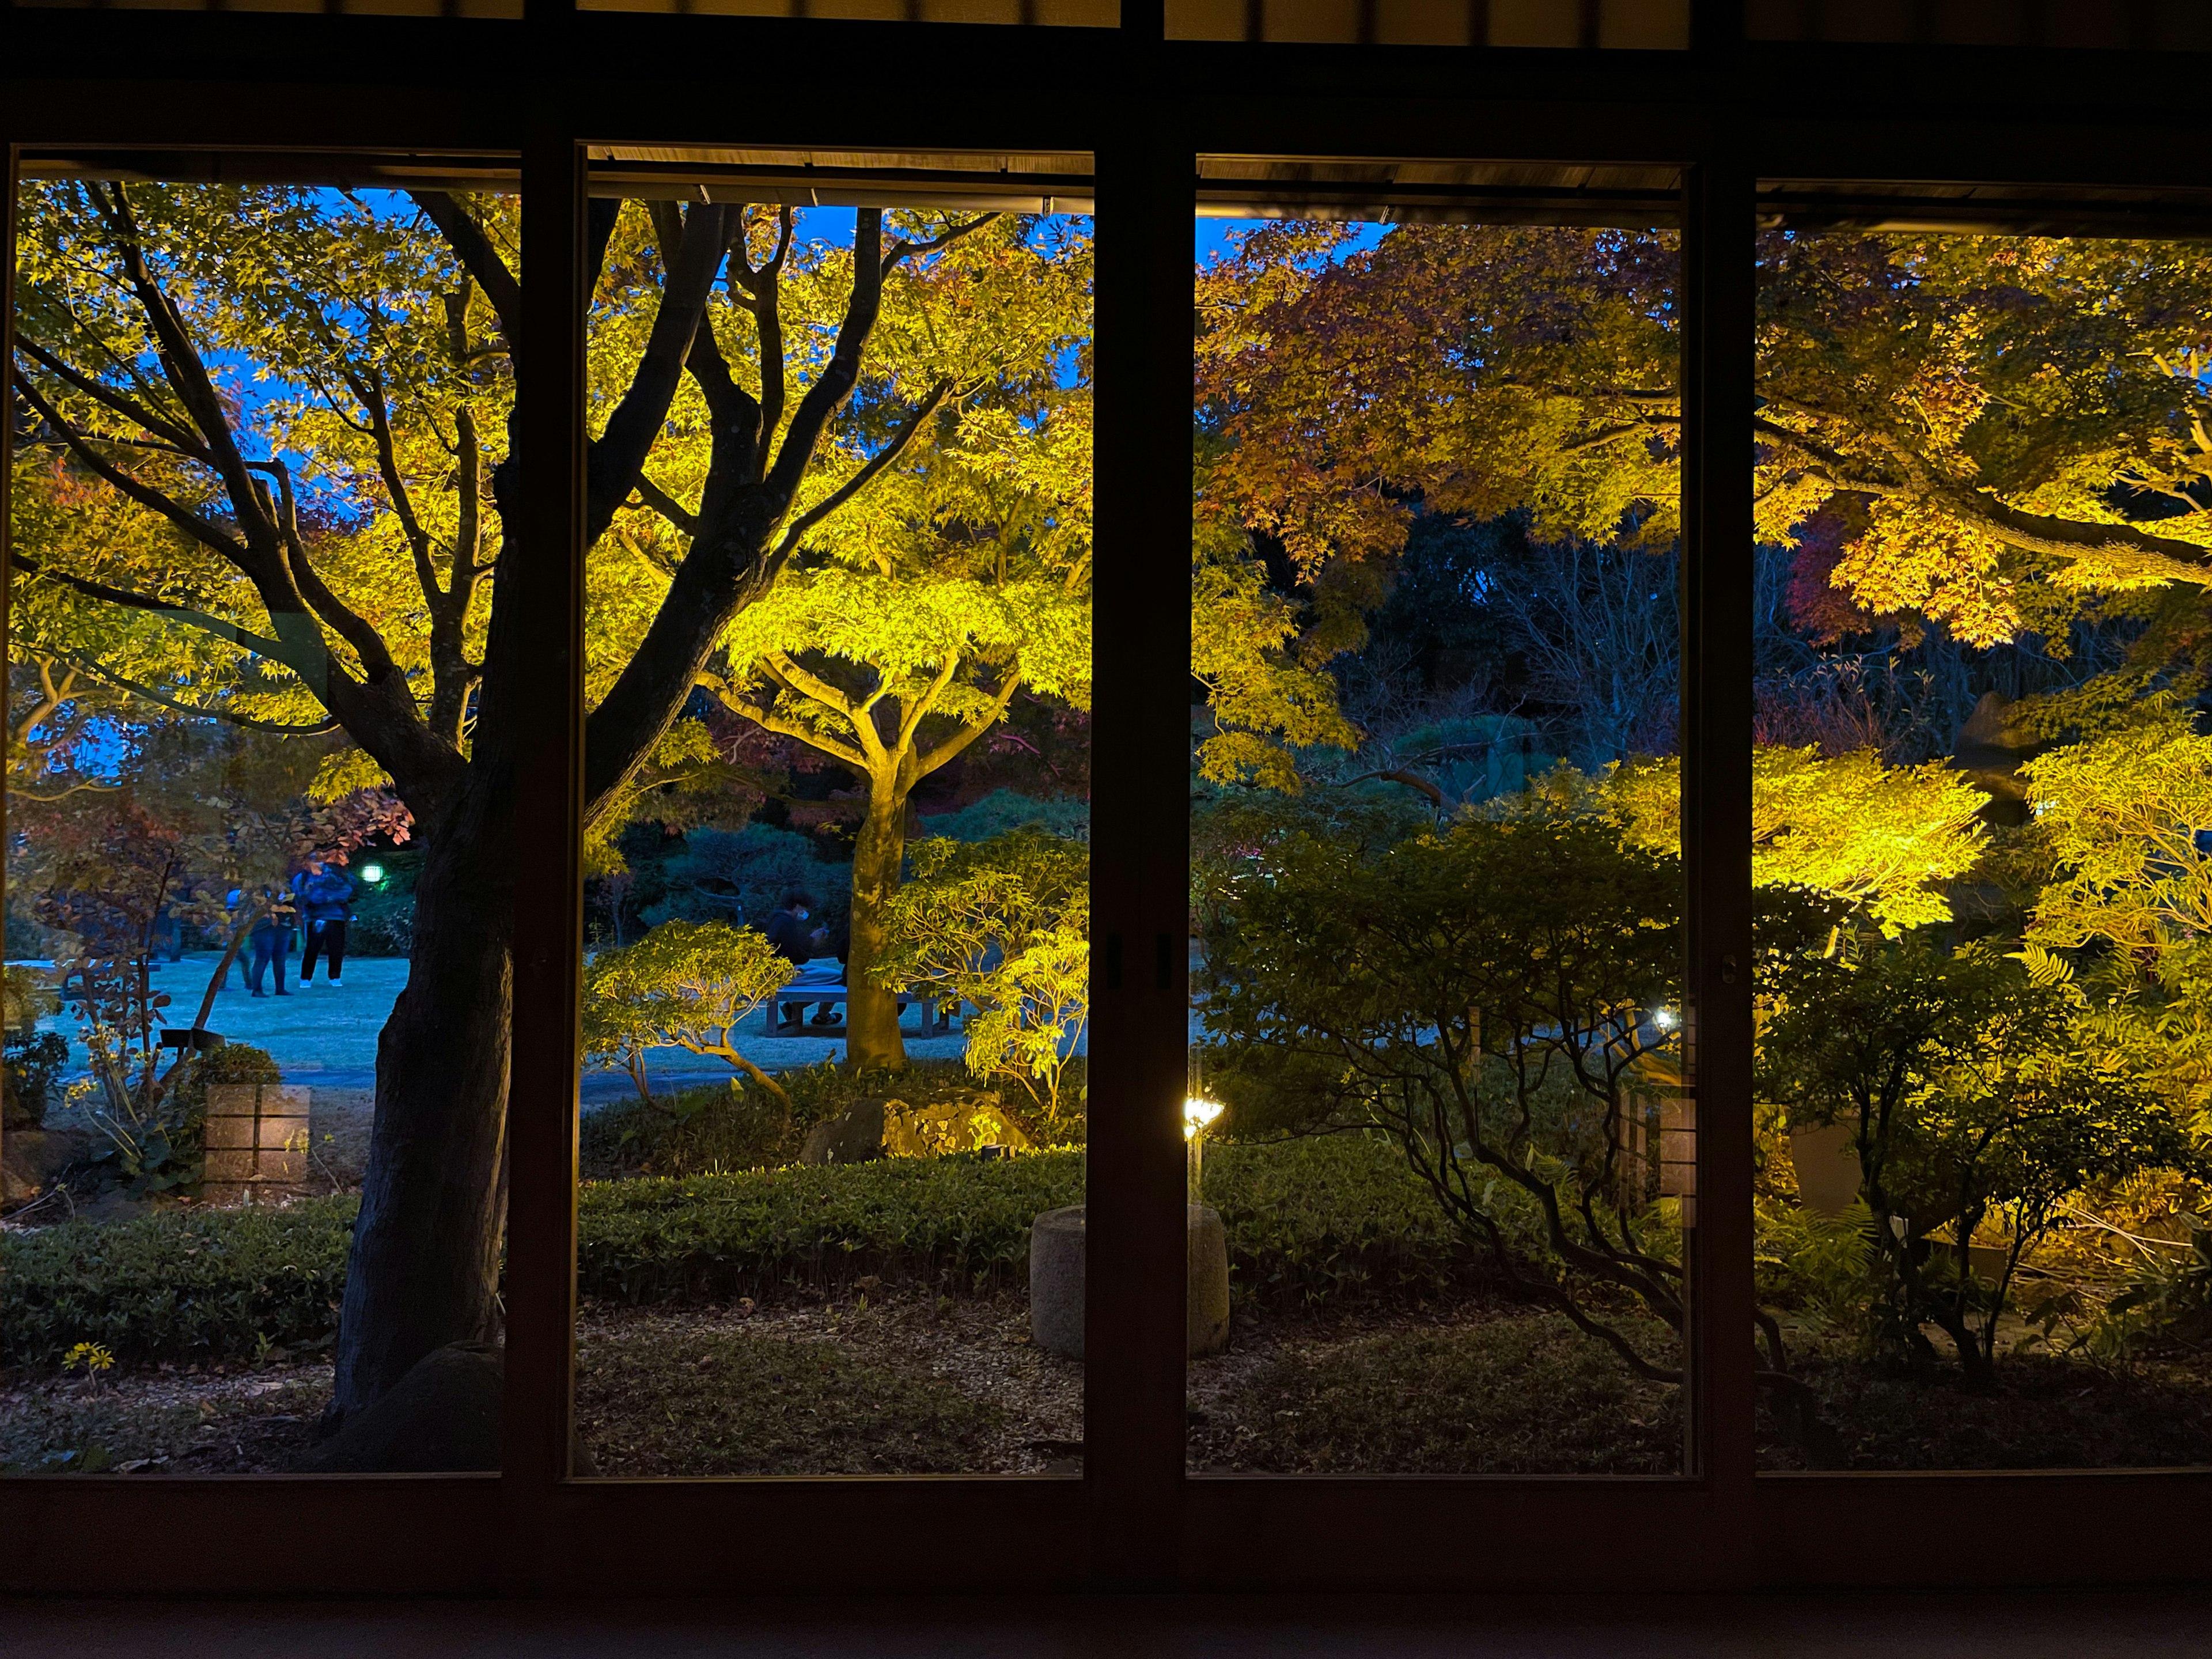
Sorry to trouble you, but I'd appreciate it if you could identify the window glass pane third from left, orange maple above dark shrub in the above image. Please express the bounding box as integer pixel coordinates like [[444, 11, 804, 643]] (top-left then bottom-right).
[[1188, 194, 1696, 1473]]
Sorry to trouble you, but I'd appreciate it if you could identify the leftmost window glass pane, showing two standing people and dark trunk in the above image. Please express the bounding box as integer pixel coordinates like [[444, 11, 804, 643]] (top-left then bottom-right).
[[0, 155, 520, 1473]]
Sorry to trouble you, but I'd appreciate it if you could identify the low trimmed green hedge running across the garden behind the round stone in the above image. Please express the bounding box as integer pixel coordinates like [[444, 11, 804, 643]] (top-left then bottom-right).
[[0, 1137, 1480, 1365]]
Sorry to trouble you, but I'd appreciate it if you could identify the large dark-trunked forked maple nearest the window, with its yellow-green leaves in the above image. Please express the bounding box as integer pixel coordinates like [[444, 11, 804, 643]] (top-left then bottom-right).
[[11, 181, 1048, 1420]]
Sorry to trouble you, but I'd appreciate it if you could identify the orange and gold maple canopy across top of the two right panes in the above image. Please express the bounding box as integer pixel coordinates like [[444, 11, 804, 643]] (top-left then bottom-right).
[[1199, 224, 2212, 688]]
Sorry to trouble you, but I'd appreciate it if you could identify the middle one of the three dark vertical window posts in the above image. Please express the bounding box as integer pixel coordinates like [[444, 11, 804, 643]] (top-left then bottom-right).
[[1084, 104, 1196, 1588]]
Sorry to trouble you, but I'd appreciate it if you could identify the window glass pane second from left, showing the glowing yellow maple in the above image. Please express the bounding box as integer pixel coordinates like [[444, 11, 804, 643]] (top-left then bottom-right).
[[577, 169, 1090, 1475]]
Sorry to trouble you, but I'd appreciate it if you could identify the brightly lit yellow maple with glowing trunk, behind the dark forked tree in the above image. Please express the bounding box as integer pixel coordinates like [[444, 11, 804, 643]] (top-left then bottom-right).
[[597, 210, 1090, 1069]]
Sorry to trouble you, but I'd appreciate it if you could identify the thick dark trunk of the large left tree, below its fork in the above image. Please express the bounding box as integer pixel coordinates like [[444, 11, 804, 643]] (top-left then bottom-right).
[[329, 774, 516, 1427]]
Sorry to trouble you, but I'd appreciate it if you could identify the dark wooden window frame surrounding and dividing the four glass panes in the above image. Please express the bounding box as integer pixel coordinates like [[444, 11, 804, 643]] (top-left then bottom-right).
[[0, 0, 2212, 1595]]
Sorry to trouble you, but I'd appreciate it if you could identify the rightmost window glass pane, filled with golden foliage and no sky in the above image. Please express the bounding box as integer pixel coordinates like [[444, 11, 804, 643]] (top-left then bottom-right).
[[1752, 224, 2212, 1469]]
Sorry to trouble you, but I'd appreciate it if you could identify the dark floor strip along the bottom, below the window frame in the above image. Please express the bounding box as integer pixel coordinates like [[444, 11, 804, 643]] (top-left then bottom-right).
[[0, 1590, 2212, 1659]]
